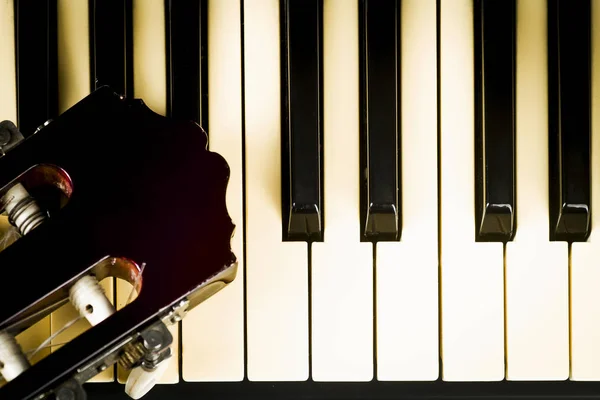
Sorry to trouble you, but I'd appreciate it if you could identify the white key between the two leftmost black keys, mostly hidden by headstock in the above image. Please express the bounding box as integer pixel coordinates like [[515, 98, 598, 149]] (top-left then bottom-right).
[[50, 0, 114, 382]]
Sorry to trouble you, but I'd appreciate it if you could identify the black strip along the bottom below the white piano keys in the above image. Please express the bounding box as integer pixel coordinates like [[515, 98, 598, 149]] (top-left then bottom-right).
[[86, 380, 600, 400]]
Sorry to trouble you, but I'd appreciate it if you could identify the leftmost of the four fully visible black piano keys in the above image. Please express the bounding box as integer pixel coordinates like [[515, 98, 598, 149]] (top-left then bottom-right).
[[280, 0, 323, 241]]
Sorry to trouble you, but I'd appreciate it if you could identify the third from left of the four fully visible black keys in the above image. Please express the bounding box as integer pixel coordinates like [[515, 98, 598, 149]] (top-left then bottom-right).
[[474, 0, 516, 242]]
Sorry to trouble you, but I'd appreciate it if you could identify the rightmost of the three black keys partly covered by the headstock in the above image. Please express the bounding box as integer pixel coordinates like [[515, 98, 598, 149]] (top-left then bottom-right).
[[165, 0, 209, 128]]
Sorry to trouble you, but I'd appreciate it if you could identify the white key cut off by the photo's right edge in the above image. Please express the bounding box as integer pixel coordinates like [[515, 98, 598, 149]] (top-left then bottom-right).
[[570, 1, 600, 381]]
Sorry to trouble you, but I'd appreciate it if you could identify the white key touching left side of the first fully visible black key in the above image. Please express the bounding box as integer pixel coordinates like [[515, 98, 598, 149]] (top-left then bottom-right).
[[244, 0, 309, 381]]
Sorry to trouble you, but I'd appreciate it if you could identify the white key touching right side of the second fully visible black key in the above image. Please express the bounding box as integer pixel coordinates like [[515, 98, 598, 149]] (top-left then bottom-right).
[[376, 0, 439, 381]]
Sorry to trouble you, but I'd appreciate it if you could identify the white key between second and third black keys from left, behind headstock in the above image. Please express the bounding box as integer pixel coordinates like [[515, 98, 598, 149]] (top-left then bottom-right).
[[116, 0, 179, 384]]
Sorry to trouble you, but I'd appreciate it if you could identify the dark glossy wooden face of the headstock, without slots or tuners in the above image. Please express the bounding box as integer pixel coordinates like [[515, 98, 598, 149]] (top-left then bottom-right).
[[0, 88, 235, 399]]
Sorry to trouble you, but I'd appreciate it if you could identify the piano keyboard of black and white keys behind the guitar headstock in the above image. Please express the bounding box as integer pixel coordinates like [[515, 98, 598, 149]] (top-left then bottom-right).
[[0, 0, 600, 399]]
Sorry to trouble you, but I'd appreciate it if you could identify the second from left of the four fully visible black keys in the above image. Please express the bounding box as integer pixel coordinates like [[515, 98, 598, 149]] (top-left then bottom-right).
[[359, 0, 402, 241]]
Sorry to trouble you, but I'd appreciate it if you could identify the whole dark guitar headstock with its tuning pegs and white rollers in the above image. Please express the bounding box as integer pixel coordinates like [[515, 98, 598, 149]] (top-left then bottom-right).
[[0, 87, 237, 399]]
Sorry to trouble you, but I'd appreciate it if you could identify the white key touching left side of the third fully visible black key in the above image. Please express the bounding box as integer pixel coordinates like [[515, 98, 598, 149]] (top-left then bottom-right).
[[440, 0, 504, 381]]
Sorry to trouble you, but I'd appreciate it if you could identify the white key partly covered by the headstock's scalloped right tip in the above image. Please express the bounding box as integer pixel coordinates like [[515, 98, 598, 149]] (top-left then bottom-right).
[[182, 0, 245, 381]]
